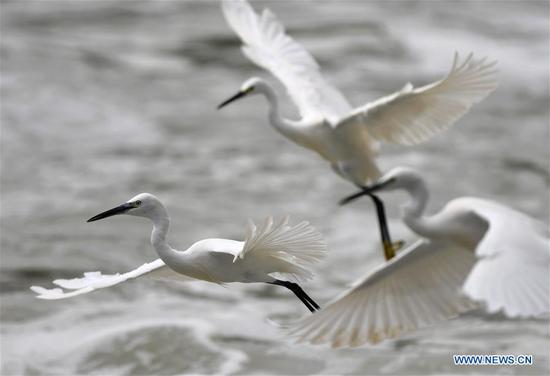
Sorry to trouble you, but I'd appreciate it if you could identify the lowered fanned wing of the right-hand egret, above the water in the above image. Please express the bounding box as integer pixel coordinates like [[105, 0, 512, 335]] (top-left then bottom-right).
[[290, 240, 475, 347]]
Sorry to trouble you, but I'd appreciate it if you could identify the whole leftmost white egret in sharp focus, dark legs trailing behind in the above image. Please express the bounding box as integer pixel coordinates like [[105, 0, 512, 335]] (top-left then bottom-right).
[[31, 193, 326, 312]]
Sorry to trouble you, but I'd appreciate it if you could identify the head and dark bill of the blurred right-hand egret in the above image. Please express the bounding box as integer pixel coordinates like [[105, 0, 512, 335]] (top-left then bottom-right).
[[340, 167, 423, 205]]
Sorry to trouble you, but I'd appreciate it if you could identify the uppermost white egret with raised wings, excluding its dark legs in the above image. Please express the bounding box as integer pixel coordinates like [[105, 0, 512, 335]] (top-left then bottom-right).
[[218, 0, 497, 186]]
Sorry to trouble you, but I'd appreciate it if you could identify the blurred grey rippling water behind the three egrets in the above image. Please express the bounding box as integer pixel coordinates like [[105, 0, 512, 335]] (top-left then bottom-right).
[[0, 1, 550, 375]]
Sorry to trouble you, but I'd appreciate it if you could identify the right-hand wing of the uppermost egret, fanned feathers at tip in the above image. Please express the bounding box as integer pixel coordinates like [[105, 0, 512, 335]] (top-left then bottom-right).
[[337, 53, 497, 145]]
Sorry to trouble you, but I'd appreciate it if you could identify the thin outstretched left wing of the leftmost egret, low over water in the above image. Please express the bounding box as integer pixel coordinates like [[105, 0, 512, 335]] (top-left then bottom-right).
[[31, 259, 189, 300]]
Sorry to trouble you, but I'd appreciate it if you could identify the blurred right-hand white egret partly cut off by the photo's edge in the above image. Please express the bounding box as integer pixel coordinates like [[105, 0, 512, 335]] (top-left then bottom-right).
[[291, 167, 550, 347]]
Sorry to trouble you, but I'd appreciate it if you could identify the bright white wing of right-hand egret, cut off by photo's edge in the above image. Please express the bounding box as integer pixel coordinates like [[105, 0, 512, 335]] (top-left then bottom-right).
[[463, 198, 550, 317]]
